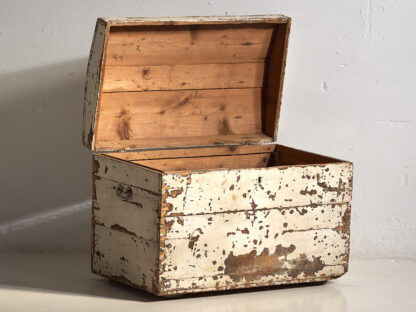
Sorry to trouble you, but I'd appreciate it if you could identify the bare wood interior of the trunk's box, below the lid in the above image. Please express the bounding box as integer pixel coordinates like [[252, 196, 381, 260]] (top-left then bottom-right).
[[106, 144, 341, 173]]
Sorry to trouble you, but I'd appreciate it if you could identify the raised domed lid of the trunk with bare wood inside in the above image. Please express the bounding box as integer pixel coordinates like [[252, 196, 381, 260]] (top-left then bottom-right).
[[83, 15, 290, 152]]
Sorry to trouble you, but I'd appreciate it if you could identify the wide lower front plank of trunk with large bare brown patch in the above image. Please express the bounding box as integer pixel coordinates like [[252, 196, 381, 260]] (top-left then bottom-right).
[[161, 204, 350, 282]]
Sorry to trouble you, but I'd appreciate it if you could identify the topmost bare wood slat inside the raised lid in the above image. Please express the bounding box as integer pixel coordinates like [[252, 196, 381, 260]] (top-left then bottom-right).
[[106, 25, 273, 66]]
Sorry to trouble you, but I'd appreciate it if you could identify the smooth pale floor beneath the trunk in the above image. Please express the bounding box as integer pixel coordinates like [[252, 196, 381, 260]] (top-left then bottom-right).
[[0, 253, 416, 312]]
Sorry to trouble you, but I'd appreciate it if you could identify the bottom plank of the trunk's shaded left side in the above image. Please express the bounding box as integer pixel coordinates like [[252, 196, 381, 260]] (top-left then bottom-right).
[[92, 225, 159, 293]]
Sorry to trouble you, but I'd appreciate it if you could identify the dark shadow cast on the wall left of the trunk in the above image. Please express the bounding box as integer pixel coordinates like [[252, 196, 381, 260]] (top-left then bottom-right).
[[0, 58, 91, 251]]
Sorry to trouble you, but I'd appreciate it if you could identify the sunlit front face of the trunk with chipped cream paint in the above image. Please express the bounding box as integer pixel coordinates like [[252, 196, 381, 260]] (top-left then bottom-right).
[[155, 162, 352, 294]]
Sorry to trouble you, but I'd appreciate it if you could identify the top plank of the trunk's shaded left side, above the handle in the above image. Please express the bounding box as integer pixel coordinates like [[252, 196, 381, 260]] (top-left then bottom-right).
[[93, 154, 161, 195]]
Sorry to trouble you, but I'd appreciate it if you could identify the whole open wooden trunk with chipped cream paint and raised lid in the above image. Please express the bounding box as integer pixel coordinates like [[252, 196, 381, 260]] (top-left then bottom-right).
[[83, 15, 352, 296]]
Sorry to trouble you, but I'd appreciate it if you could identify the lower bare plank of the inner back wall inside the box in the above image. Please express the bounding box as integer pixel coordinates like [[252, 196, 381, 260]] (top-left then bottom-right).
[[133, 153, 270, 172]]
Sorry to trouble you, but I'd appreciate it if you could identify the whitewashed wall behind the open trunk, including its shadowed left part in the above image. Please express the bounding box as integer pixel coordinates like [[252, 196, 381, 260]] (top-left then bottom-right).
[[0, 0, 416, 258]]
